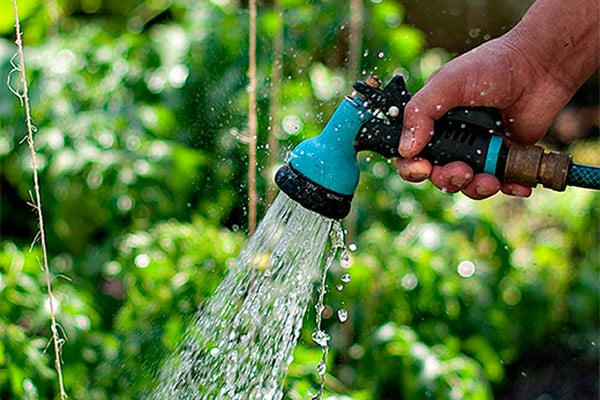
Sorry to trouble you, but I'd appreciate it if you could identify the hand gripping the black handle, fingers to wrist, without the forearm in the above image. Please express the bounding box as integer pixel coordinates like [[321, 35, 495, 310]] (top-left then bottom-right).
[[397, 36, 572, 199]]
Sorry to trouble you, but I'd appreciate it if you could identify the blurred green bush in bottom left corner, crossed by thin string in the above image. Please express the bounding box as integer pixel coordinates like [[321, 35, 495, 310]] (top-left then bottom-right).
[[0, 242, 100, 399]]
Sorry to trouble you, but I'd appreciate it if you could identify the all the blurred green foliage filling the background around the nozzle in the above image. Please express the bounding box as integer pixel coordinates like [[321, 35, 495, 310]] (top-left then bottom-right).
[[0, 0, 600, 400]]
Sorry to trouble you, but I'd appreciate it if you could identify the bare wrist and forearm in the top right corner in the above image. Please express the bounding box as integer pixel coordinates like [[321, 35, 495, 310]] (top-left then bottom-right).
[[506, 0, 600, 91]]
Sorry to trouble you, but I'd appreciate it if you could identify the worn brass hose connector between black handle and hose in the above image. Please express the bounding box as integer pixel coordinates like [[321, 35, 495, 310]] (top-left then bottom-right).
[[504, 143, 571, 191]]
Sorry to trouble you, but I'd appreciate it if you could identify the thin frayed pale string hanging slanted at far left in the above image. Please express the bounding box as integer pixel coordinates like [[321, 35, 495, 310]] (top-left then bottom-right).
[[9, 0, 67, 400]]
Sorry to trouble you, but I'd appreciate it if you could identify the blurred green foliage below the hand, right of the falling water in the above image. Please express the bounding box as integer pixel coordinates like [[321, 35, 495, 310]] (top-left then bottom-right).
[[310, 177, 600, 399]]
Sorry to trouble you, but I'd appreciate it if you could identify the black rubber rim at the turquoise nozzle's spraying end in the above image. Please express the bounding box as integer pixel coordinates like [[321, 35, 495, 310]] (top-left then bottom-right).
[[275, 165, 353, 219]]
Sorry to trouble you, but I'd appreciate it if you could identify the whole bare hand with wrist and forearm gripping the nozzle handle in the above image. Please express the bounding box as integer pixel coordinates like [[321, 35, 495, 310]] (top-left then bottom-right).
[[396, 0, 600, 199]]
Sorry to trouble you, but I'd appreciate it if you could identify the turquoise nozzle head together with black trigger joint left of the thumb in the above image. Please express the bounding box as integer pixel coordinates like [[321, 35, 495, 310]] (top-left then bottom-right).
[[275, 75, 410, 219]]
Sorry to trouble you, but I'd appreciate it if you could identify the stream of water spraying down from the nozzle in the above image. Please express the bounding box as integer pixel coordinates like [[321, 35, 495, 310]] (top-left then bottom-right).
[[147, 194, 343, 400]]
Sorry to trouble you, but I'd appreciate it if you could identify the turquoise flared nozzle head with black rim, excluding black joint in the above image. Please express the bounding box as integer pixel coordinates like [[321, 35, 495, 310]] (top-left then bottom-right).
[[275, 98, 373, 219]]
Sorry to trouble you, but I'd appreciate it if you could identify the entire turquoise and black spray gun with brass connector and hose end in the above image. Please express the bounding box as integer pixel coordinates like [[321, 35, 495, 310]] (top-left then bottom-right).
[[275, 75, 600, 219]]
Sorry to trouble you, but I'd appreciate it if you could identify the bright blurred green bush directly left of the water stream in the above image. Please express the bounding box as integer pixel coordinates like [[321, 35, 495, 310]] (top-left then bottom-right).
[[92, 219, 242, 399]]
